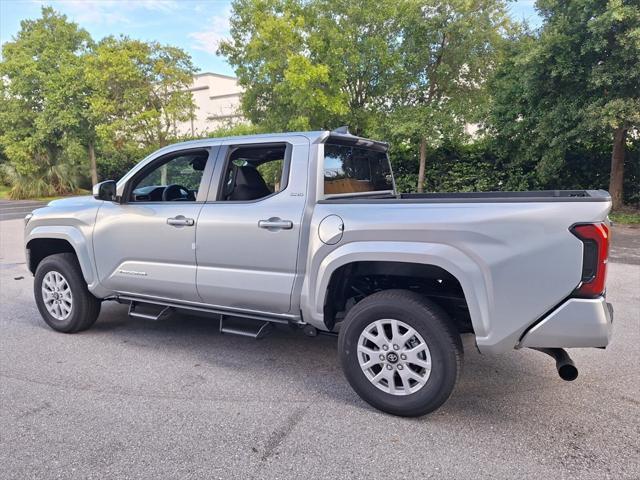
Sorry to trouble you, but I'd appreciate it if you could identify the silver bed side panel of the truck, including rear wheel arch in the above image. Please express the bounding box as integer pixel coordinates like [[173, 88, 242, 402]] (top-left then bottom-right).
[[301, 200, 610, 352]]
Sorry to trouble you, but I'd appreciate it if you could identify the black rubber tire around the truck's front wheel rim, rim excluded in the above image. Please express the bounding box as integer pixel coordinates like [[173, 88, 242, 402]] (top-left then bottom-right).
[[33, 253, 101, 333]]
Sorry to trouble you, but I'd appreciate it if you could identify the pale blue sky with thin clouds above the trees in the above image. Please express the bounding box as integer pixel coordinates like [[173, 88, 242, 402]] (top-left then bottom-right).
[[0, 0, 540, 75]]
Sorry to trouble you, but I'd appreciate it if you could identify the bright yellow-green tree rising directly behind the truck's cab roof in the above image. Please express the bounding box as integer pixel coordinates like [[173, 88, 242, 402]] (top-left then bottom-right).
[[219, 0, 399, 133]]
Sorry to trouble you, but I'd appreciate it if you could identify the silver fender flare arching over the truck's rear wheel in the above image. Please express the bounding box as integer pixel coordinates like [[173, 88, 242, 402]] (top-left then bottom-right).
[[302, 241, 493, 339]]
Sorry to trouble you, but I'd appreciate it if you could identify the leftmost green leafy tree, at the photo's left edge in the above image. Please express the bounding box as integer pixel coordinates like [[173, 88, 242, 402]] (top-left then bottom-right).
[[0, 7, 92, 197]]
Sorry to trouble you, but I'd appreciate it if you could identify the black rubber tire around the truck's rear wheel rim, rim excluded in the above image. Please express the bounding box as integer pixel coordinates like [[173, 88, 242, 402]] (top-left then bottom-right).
[[338, 290, 463, 417]]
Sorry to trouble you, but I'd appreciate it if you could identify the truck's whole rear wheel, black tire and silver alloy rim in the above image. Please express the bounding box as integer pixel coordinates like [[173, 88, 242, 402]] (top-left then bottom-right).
[[338, 290, 462, 417]]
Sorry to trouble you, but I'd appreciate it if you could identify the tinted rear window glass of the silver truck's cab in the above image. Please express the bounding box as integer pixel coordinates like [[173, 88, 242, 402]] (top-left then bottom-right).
[[324, 144, 393, 195]]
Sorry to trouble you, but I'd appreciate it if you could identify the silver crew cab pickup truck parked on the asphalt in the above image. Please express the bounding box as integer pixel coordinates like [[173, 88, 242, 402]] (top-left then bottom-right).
[[25, 131, 612, 416]]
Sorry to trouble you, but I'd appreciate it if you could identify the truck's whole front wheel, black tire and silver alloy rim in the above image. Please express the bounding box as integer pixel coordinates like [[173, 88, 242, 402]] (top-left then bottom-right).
[[33, 253, 100, 333]]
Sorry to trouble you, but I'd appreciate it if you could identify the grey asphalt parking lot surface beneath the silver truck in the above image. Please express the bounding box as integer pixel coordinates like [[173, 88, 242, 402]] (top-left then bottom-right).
[[0, 215, 640, 480]]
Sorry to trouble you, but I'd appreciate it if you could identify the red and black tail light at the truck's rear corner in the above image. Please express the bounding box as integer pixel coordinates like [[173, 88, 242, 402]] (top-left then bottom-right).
[[571, 223, 609, 298]]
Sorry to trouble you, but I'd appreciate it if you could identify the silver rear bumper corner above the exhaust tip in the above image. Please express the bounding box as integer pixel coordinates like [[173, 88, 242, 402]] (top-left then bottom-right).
[[517, 297, 613, 348]]
